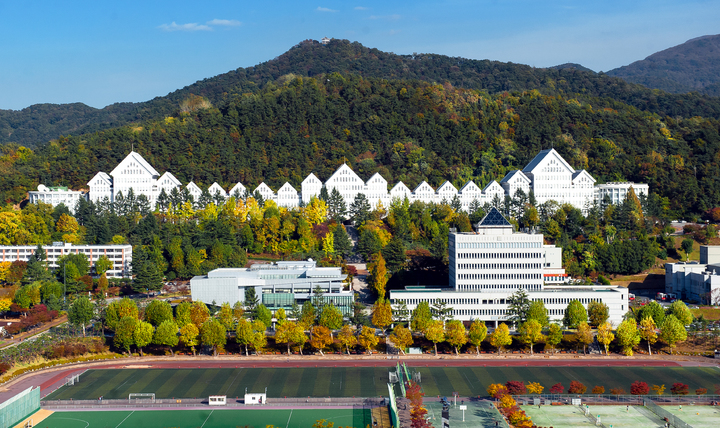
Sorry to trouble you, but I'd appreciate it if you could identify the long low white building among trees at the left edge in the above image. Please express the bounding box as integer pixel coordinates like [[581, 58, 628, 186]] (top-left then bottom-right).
[[0, 242, 132, 278]]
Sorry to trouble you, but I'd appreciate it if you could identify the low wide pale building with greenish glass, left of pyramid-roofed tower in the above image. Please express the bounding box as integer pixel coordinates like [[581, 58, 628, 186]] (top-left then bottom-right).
[[190, 259, 353, 315]]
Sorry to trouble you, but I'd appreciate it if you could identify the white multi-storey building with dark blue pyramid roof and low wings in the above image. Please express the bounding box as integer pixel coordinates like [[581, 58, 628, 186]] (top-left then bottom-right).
[[390, 208, 628, 328]]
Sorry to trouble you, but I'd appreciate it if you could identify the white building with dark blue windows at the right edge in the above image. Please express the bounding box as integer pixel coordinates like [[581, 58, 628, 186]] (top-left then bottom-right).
[[665, 245, 720, 305]]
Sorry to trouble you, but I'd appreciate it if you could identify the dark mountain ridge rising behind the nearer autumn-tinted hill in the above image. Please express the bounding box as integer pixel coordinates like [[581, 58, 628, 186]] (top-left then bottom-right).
[[0, 40, 720, 147]]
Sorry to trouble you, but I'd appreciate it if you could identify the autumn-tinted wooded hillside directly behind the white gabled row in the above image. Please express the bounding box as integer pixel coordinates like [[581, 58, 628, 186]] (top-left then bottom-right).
[[0, 73, 720, 218]]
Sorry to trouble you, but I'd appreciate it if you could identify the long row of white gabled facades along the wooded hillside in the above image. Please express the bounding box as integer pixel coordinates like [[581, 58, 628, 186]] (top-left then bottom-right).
[[88, 149, 649, 211]]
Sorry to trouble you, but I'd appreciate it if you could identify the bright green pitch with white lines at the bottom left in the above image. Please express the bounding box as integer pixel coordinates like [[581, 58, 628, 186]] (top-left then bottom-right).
[[35, 409, 372, 428]]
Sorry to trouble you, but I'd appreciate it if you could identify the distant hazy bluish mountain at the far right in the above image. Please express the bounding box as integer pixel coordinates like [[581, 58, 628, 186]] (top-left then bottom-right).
[[607, 35, 720, 96]]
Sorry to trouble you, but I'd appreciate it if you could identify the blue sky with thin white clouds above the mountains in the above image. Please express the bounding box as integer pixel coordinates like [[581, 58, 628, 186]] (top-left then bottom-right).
[[0, 0, 720, 110]]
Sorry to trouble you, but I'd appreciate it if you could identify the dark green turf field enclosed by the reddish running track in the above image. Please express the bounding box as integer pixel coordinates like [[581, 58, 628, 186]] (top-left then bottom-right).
[[45, 366, 720, 400]]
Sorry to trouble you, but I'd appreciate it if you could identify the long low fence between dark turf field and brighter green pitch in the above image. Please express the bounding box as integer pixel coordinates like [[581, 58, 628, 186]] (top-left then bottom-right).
[[40, 397, 387, 410]]
